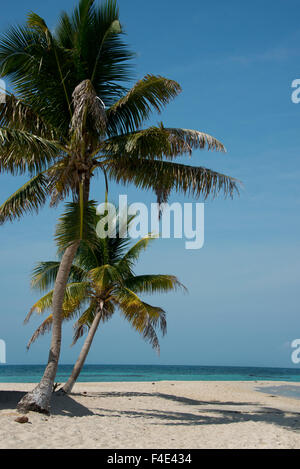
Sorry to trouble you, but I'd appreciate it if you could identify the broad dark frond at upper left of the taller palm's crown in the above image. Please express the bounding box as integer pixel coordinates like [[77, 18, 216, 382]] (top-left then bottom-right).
[[0, 23, 72, 136]]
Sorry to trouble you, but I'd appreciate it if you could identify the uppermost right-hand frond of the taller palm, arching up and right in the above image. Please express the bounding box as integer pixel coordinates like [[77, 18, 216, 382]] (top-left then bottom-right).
[[107, 75, 181, 135]]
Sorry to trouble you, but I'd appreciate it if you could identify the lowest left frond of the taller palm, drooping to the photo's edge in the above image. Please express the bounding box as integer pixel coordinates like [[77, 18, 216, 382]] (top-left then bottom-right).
[[0, 173, 50, 225]]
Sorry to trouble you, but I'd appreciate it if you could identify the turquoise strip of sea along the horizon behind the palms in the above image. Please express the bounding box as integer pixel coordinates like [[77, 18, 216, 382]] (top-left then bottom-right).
[[0, 365, 300, 389]]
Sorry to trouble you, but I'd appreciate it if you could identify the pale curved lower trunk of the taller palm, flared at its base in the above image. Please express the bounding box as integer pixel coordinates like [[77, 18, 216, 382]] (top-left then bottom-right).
[[17, 242, 79, 414]]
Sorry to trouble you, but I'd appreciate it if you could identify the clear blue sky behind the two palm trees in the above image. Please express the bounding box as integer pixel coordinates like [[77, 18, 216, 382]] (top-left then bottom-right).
[[0, 0, 300, 367]]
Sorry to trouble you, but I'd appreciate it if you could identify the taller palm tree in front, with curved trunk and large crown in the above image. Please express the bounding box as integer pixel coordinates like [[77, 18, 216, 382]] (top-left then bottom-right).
[[0, 0, 238, 413]]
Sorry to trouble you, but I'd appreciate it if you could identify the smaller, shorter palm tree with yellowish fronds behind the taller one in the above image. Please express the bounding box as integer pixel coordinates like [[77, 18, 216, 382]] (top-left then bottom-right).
[[25, 203, 185, 393]]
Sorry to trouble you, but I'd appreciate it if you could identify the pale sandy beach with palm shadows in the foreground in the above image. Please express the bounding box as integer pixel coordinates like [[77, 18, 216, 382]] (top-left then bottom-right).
[[0, 381, 300, 449]]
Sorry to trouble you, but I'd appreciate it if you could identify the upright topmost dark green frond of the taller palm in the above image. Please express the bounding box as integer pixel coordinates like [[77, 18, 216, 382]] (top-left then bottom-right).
[[54, 0, 133, 106]]
